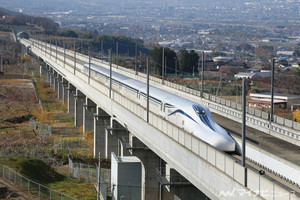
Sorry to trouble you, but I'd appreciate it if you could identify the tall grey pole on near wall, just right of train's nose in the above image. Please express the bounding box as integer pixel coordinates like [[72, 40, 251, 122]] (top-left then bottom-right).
[[242, 78, 247, 187]]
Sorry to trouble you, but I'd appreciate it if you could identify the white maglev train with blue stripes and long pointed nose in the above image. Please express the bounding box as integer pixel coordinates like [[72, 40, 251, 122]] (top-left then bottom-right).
[[82, 63, 235, 152]]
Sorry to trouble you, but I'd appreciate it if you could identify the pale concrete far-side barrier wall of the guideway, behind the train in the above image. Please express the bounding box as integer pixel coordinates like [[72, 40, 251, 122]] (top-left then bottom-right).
[[30, 39, 300, 146]]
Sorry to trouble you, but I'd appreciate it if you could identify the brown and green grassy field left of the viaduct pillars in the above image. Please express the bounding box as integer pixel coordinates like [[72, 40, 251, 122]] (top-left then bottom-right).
[[0, 43, 96, 200]]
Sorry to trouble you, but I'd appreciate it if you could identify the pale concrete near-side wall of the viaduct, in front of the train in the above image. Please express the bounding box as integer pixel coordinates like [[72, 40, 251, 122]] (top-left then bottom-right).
[[20, 39, 299, 199]]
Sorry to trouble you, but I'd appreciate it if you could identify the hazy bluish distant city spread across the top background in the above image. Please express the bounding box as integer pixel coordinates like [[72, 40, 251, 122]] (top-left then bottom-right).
[[0, 0, 300, 51]]
